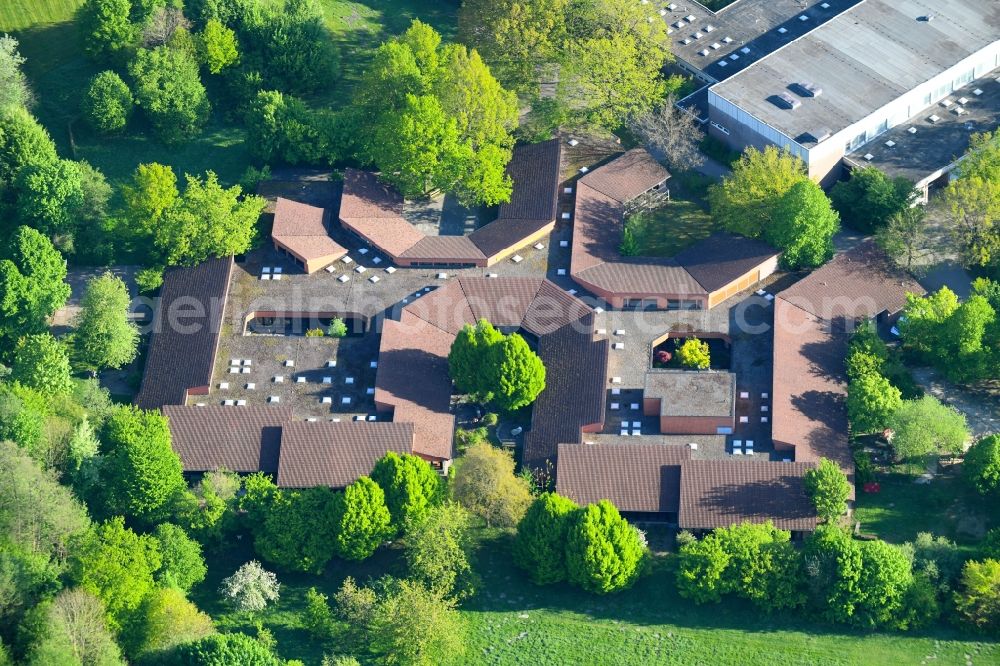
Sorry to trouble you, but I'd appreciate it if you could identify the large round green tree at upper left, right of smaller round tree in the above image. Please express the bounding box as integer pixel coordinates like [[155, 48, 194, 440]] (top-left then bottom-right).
[[129, 46, 212, 144]]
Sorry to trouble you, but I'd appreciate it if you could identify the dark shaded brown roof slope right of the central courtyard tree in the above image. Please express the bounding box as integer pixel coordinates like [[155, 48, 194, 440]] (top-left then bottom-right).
[[524, 312, 610, 467]]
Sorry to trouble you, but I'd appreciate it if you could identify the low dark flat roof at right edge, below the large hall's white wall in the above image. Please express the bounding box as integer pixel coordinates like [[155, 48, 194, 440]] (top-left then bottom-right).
[[847, 69, 1000, 185]]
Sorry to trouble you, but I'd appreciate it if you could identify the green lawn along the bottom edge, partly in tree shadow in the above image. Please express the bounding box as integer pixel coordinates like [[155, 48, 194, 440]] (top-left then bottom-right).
[[194, 533, 1000, 666]]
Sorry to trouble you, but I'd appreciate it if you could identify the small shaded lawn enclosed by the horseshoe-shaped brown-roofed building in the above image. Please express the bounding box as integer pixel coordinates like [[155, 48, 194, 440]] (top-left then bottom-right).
[[626, 198, 716, 257]]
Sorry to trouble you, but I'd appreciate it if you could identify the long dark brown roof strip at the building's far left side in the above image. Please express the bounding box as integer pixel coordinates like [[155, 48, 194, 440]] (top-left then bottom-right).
[[136, 257, 233, 409]]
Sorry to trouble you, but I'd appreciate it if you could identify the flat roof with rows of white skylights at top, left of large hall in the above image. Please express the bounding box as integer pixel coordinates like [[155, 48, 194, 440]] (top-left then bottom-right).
[[663, 0, 860, 81]]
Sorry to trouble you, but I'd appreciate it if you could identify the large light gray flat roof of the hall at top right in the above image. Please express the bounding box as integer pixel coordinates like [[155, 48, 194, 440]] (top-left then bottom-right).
[[710, 0, 1000, 144]]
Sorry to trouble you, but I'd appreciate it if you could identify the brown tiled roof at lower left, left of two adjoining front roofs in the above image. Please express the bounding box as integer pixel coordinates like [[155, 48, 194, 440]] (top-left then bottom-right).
[[163, 405, 292, 474]]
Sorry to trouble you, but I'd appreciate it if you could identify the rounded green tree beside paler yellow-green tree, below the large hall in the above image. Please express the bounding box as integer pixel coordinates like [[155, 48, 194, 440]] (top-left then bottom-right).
[[764, 180, 840, 269]]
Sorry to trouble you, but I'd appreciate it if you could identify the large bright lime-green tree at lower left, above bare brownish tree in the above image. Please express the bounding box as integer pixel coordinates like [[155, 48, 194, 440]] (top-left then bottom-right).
[[70, 516, 160, 630]]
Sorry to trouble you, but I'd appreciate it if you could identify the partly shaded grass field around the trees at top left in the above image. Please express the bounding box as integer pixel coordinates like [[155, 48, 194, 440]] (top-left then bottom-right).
[[0, 0, 457, 191]]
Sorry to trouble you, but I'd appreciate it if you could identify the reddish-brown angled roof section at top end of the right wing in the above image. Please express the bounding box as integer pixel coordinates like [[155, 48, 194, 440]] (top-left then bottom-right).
[[781, 241, 925, 320]]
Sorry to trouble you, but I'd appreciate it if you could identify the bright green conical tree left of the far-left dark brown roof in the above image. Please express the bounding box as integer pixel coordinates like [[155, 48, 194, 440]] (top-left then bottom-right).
[[73, 272, 139, 370]]
